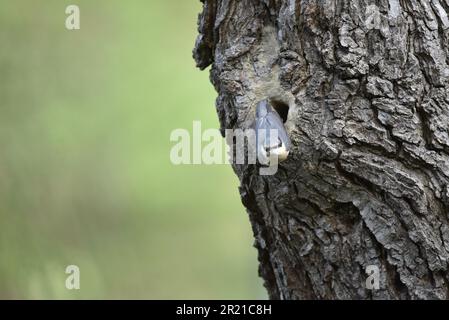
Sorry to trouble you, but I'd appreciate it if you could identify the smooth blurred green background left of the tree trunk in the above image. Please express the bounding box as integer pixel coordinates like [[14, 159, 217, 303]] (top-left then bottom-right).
[[0, 0, 266, 299]]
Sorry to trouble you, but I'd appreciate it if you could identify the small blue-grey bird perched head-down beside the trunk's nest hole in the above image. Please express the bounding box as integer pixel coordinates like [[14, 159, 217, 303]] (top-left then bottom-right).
[[255, 100, 291, 164]]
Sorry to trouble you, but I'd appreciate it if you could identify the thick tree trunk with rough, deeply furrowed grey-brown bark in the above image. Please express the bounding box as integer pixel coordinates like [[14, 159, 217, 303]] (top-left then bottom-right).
[[194, 0, 449, 299]]
